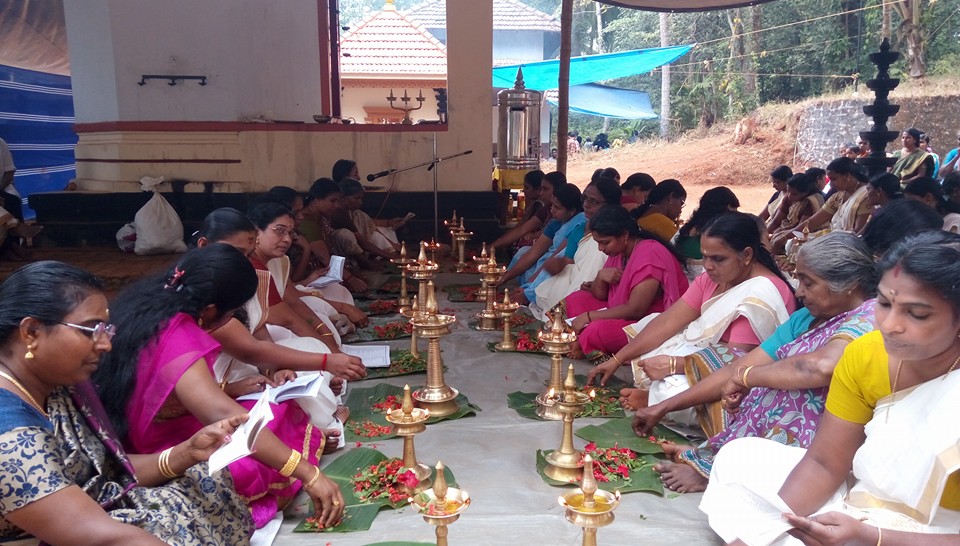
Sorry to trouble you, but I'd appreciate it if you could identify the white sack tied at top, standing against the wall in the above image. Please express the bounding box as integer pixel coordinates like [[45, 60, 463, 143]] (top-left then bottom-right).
[[133, 176, 187, 256]]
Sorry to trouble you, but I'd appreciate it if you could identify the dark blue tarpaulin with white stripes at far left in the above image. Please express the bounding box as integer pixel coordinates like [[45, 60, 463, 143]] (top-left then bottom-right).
[[0, 65, 77, 218]]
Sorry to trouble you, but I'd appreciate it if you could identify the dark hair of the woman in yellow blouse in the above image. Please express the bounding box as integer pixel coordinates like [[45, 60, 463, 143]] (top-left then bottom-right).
[[879, 230, 960, 316]]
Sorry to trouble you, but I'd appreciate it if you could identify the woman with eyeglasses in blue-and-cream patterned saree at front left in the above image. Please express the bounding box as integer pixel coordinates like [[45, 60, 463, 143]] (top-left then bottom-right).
[[0, 262, 253, 546]]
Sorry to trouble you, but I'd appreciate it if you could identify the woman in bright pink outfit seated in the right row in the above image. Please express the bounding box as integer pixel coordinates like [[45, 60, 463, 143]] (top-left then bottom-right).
[[565, 205, 689, 358]]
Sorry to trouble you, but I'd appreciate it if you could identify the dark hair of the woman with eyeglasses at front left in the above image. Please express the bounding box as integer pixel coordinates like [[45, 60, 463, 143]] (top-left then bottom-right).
[[0, 260, 103, 345]]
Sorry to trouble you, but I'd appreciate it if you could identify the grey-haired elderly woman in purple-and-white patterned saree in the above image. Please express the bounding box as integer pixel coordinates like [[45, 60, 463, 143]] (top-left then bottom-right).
[[633, 232, 877, 493]]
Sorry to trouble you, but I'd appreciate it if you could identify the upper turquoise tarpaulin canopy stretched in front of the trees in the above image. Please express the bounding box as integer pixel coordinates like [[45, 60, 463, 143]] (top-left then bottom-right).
[[493, 44, 693, 91]]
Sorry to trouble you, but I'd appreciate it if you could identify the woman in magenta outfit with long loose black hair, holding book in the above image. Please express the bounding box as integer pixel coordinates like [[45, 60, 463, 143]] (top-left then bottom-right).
[[95, 244, 343, 528]]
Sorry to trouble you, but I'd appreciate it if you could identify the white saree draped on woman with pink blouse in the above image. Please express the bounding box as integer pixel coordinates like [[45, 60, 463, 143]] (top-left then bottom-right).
[[623, 277, 790, 426]]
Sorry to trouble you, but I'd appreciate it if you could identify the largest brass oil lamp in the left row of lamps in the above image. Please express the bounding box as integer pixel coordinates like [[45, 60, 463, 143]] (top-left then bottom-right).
[[411, 281, 460, 417]]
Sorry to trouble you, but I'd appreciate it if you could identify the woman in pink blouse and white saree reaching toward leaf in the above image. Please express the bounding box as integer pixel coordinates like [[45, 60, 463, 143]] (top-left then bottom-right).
[[587, 212, 796, 425]]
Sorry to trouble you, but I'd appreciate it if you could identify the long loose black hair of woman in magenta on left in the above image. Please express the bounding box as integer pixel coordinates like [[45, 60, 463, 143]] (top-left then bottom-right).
[[93, 243, 258, 439]]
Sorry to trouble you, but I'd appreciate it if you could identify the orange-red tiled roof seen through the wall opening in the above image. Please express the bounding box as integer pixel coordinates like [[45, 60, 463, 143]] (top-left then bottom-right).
[[340, 2, 447, 81]]
